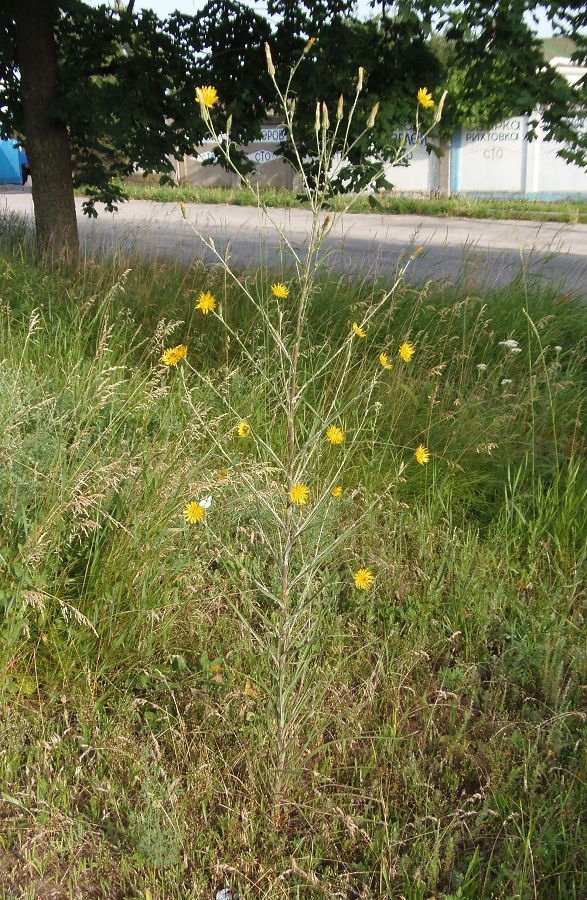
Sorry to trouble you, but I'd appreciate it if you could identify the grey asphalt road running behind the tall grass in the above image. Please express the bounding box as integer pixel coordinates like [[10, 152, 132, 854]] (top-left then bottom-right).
[[0, 190, 587, 299]]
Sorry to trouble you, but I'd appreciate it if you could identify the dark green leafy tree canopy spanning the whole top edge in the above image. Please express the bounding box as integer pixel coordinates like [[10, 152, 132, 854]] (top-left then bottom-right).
[[0, 0, 587, 256]]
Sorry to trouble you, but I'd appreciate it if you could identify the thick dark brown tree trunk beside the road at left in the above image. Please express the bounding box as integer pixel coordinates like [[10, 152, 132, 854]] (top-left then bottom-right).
[[13, 0, 79, 262]]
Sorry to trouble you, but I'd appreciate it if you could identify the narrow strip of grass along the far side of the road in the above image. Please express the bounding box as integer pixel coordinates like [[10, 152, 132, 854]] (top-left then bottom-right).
[[116, 183, 587, 224]]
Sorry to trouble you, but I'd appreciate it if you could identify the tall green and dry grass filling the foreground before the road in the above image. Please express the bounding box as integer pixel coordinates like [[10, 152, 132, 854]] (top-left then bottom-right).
[[0, 213, 587, 900]]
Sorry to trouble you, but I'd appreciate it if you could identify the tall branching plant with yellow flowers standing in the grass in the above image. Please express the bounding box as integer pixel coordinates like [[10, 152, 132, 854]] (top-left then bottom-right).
[[162, 51, 444, 818]]
